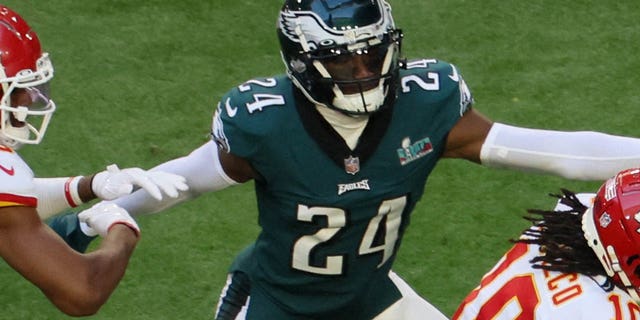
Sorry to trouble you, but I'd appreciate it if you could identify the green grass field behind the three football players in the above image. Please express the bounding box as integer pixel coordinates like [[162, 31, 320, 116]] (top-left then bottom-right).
[[0, 0, 640, 320]]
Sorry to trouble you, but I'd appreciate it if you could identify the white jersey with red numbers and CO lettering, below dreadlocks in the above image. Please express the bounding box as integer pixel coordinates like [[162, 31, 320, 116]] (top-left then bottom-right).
[[452, 243, 640, 320]]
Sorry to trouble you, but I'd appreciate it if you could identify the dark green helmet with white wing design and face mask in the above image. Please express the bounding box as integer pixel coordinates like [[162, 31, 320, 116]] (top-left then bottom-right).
[[278, 0, 402, 115]]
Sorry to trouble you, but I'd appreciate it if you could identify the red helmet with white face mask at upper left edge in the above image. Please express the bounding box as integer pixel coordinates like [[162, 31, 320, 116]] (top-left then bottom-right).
[[0, 5, 56, 148]]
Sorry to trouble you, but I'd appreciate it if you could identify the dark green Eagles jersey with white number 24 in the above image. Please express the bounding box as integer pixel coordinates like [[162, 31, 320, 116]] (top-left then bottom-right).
[[214, 59, 471, 319]]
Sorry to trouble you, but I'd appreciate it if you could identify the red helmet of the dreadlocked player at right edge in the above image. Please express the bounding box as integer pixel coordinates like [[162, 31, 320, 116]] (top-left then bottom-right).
[[582, 168, 640, 302]]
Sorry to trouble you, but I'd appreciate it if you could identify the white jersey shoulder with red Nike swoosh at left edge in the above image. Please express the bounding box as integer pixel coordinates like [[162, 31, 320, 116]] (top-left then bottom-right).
[[0, 146, 38, 207]]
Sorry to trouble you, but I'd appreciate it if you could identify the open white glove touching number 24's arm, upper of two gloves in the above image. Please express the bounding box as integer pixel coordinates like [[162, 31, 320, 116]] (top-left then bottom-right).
[[91, 164, 189, 200]]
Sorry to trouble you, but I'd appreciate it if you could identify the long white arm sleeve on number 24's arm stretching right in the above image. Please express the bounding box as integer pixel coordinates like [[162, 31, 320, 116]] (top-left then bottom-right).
[[480, 123, 640, 181]]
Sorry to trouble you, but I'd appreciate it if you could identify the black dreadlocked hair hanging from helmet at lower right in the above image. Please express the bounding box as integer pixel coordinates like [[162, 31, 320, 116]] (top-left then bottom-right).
[[511, 189, 606, 276]]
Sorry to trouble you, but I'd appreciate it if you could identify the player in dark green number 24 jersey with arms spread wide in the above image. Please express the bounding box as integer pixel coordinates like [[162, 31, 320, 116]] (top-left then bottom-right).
[[53, 0, 640, 320]]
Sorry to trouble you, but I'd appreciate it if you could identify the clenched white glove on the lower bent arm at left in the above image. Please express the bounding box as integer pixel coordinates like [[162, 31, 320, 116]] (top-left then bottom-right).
[[78, 202, 140, 237]]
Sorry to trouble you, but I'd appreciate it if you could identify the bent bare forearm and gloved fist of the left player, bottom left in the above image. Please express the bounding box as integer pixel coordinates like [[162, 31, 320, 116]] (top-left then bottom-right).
[[0, 207, 139, 316]]
